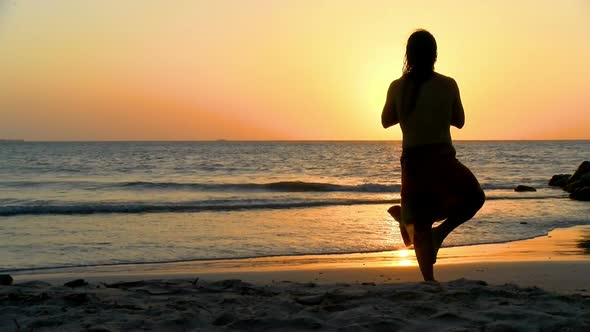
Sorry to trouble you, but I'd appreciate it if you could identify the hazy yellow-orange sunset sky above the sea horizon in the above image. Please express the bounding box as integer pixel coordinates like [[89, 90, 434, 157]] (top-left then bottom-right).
[[0, 0, 590, 140]]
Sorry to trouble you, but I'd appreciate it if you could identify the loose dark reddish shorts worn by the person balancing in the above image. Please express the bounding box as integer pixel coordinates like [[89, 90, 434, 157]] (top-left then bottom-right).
[[401, 144, 485, 224]]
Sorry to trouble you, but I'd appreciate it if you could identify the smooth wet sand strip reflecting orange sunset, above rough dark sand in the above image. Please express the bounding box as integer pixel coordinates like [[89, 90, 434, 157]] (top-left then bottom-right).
[[10, 225, 590, 294]]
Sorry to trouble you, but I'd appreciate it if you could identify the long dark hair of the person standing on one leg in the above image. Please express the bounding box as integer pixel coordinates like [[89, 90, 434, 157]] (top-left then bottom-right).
[[401, 30, 437, 117]]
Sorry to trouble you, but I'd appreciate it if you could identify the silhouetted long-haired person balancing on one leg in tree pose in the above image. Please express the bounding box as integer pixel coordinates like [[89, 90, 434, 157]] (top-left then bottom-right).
[[381, 30, 485, 281]]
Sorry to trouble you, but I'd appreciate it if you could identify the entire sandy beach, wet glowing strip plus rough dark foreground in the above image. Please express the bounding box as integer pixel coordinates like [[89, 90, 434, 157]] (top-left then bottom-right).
[[0, 226, 590, 331]]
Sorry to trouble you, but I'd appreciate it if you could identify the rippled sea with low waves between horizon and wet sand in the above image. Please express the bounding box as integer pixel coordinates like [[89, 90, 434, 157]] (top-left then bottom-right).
[[0, 141, 590, 271]]
